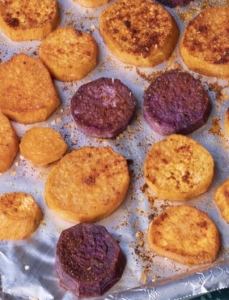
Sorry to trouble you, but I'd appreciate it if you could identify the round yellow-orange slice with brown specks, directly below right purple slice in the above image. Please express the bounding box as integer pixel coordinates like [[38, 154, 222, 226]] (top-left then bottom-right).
[[144, 134, 214, 201]]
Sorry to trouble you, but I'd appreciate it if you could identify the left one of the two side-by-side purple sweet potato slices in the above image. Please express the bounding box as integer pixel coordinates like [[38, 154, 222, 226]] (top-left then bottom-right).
[[71, 77, 136, 138]]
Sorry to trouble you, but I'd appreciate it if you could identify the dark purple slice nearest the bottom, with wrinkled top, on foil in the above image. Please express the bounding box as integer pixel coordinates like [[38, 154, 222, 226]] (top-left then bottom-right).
[[55, 223, 126, 297]]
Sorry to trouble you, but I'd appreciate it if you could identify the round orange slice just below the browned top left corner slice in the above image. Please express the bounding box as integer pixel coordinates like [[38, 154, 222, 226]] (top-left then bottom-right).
[[39, 27, 98, 81]]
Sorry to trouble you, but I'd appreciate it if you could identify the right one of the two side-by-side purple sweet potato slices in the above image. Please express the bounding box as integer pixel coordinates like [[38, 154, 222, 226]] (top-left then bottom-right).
[[143, 70, 211, 135]]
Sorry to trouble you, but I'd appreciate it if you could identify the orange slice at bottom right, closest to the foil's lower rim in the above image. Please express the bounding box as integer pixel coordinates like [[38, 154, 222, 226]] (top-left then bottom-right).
[[147, 205, 220, 266]]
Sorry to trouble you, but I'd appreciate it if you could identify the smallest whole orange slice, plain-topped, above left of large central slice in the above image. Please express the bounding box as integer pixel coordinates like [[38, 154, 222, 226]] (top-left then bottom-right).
[[20, 127, 68, 166]]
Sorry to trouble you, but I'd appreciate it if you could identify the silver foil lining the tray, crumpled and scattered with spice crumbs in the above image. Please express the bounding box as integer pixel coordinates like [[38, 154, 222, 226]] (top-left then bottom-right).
[[0, 0, 229, 300]]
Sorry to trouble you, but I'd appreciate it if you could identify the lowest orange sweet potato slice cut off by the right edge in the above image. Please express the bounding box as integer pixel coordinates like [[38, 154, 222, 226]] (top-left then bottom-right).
[[214, 178, 229, 223]]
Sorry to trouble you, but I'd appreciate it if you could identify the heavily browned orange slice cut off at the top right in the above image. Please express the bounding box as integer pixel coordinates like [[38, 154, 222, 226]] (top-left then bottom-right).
[[179, 6, 229, 78]]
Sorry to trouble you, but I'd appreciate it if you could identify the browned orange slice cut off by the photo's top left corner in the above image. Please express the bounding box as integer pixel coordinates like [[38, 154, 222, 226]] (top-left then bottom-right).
[[0, 0, 60, 41]]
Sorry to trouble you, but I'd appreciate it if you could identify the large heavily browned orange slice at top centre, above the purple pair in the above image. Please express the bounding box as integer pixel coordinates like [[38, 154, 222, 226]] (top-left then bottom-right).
[[99, 0, 179, 67]]
